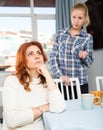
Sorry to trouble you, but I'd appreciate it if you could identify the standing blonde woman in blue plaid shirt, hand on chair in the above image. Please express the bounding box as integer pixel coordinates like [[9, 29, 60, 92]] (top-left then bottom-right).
[[50, 3, 93, 99]]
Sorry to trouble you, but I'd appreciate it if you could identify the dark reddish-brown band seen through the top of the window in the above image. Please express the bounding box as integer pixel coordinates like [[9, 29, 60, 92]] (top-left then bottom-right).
[[0, 0, 55, 7]]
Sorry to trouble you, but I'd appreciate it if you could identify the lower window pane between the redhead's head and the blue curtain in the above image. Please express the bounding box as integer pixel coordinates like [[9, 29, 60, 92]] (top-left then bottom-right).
[[37, 20, 55, 51]]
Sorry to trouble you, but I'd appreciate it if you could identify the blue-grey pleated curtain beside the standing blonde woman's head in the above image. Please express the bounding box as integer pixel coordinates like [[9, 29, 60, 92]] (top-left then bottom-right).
[[56, 0, 74, 32]]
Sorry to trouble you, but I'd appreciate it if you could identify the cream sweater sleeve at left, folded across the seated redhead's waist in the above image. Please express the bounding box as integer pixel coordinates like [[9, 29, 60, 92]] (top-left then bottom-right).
[[2, 76, 34, 128]]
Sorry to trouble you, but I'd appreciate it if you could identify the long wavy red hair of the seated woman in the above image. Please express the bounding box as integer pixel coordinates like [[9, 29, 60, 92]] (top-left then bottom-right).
[[14, 41, 47, 91]]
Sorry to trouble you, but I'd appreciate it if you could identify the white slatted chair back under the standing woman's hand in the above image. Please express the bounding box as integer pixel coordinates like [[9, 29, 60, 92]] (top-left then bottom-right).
[[54, 78, 81, 100]]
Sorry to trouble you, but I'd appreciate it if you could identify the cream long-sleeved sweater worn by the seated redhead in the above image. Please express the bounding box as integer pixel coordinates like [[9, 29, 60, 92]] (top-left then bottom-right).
[[2, 76, 66, 130]]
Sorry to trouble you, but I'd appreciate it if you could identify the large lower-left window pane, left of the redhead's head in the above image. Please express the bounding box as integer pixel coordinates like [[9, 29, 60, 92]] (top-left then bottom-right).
[[0, 17, 32, 56]]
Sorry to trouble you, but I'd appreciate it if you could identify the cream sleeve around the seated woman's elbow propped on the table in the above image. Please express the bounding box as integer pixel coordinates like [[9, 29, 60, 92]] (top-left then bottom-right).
[[48, 89, 66, 113]]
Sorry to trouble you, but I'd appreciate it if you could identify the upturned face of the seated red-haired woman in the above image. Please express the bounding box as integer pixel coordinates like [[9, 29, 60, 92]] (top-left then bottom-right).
[[26, 45, 44, 70]]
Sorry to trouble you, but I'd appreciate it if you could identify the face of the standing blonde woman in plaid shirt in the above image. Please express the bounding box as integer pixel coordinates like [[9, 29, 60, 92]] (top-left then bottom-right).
[[71, 9, 86, 30]]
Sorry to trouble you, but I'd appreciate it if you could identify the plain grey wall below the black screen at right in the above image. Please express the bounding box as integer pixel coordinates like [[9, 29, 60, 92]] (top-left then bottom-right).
[[88, 49, 103, 91]]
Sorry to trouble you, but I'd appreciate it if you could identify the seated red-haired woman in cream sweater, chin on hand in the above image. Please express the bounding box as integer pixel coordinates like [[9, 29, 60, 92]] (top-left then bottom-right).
[[2, 41, 66, 130]]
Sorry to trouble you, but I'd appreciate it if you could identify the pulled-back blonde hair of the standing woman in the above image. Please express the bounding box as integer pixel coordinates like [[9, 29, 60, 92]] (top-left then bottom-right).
[[71, 3, 90, 26]]
